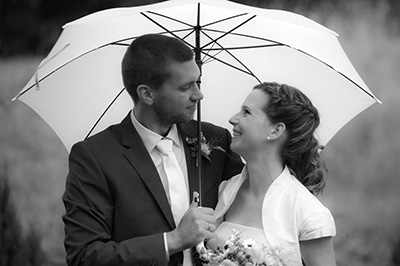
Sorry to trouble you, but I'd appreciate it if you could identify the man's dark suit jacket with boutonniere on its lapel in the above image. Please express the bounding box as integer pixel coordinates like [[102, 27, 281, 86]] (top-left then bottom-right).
[[63, 115, 243, 266]]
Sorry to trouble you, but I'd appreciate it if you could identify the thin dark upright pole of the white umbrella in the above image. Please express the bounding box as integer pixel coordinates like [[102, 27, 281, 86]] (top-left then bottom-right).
[[194, 3, 203, 206]]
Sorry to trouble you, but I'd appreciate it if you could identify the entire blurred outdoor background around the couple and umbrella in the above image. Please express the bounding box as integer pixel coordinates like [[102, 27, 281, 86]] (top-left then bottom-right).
[[0, 0, 400, 266]]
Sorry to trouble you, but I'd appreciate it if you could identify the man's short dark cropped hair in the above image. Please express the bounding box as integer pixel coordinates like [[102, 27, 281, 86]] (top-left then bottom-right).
[[122, 34, 193, 103]]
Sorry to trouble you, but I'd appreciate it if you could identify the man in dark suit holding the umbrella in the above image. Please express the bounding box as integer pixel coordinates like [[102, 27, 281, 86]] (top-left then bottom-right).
[[63, 34, 243, 265]]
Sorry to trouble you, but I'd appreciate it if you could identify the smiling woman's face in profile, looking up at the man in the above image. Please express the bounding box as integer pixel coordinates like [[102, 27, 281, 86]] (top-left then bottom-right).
[[229, 89, 273, 156]]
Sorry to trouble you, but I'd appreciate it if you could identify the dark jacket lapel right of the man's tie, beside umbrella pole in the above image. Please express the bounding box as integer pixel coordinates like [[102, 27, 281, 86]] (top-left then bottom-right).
[[177, 123, 199, 201]]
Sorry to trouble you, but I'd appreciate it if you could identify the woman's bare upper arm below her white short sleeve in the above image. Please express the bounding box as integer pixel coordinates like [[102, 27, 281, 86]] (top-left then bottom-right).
[[300, 237, 336, 266]]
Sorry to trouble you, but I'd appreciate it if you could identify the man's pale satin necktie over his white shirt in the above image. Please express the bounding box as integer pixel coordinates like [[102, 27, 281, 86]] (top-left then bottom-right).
[[157, 138, 189, 226]]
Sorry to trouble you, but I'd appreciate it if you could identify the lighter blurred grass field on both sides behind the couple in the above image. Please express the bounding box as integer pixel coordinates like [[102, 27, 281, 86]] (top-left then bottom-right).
[[0, 1, 400, 266]]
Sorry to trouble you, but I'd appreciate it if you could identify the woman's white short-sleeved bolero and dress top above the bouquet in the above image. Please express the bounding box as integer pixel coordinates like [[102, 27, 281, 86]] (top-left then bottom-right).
[[214, 166, 336, 266]]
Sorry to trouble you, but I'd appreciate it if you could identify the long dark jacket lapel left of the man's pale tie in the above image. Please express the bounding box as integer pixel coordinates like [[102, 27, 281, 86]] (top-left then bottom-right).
[[121, 115, 175, 228]]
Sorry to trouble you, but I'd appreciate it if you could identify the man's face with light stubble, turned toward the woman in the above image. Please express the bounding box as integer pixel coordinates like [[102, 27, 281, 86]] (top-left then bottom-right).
[[154, 60, 203, 125]]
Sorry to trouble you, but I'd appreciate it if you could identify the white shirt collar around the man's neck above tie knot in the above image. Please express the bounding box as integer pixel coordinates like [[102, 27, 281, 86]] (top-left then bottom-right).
[[131, 110, 180, 153]]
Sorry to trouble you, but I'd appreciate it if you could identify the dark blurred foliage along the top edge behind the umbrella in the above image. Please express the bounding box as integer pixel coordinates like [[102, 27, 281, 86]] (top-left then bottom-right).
[[0, 0, 400, 56]]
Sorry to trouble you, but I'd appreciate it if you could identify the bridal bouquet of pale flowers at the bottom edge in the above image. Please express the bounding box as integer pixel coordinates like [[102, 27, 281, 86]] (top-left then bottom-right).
[[197, 230, 289, 266]]
